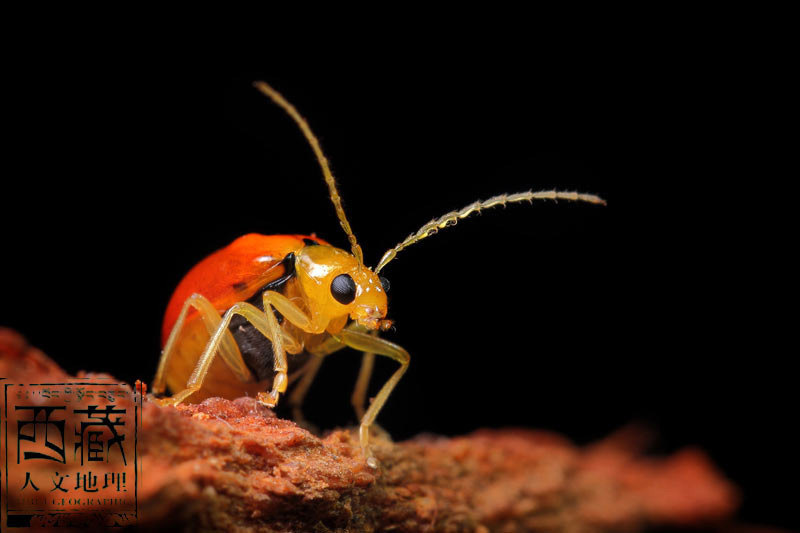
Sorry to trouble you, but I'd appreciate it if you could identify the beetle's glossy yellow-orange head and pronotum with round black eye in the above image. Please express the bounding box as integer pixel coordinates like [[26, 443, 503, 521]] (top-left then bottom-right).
[[296, 245, 392, 330]]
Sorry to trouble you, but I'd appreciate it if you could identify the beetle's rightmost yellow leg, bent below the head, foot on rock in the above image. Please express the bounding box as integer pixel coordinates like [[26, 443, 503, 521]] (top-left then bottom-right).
[[335, 329, 410, 468]]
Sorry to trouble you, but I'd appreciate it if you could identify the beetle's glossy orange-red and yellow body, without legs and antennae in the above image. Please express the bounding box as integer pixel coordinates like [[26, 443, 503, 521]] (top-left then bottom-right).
[[162, 234, 387, 402]]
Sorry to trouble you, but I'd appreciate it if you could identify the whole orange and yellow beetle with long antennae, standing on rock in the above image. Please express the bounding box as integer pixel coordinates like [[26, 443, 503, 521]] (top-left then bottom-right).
[[151, 82, 605, 468]]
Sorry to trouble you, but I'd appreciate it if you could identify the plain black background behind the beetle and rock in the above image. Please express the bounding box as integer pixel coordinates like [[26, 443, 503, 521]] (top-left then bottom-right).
[[0, 18, 797, 526]]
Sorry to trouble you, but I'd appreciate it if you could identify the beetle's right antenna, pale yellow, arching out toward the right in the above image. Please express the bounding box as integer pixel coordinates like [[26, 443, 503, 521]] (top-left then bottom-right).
[[375, 191, 606, 274]]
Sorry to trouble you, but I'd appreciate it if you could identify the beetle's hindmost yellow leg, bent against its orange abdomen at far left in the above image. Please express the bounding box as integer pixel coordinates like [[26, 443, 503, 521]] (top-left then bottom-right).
[[152, 293, 253, 395]]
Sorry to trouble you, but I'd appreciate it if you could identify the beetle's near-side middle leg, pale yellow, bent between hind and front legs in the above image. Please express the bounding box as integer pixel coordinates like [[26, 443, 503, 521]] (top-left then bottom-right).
[[162, 302, 294, 405]]
